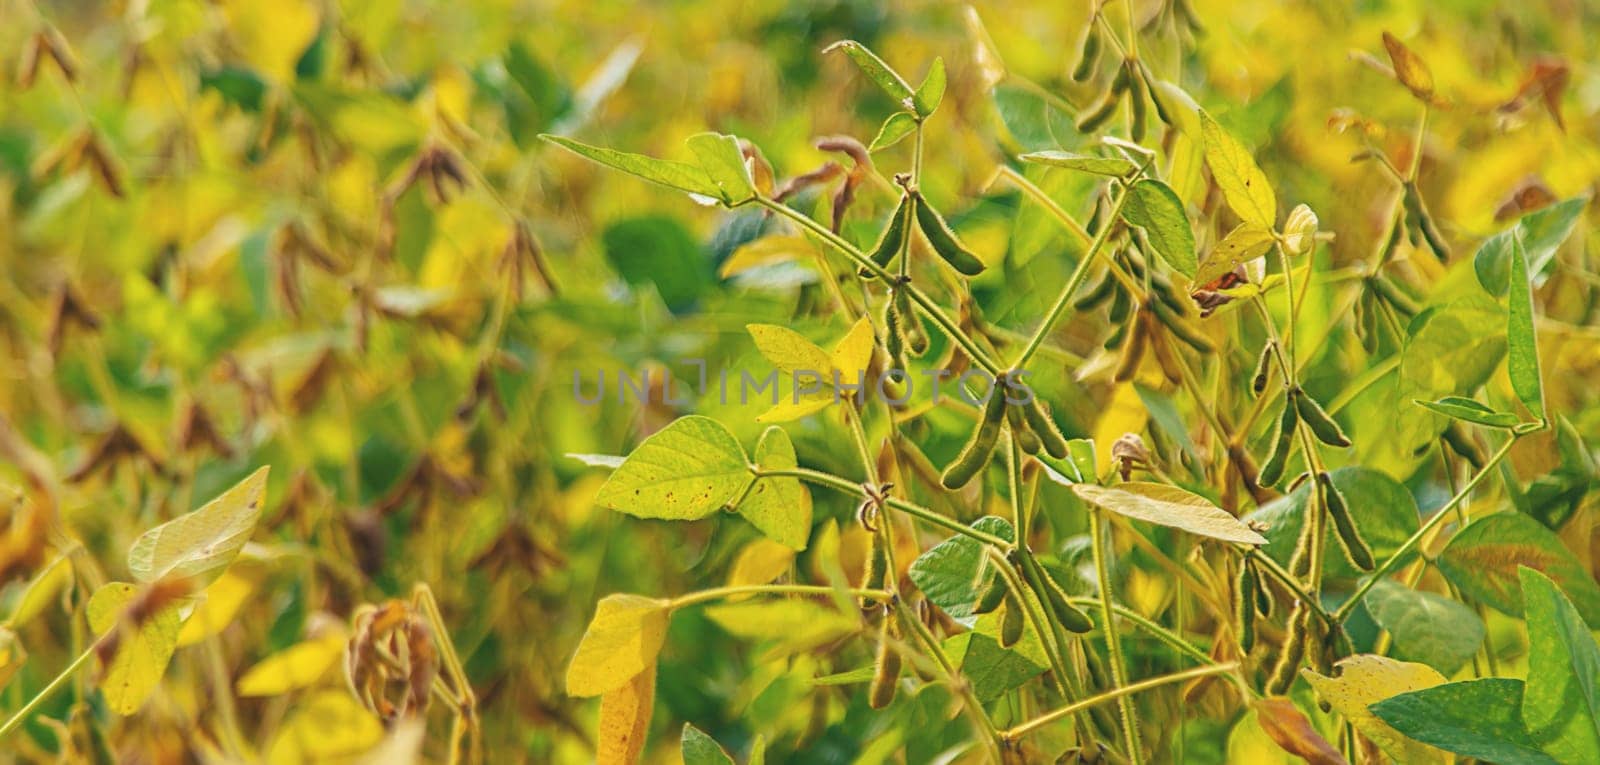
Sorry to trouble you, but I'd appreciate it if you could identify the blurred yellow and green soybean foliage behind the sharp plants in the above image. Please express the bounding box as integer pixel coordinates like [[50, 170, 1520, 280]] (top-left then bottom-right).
[[0, 0, 1600, 762]]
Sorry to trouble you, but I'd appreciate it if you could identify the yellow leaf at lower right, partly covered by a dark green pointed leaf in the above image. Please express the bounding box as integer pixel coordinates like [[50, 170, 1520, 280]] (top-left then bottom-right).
[[1301, 655, 1450, 763]]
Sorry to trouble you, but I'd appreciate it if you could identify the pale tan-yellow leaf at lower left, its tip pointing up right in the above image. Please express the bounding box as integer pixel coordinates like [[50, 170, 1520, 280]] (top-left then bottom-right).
[[128, 467, 270, 589]]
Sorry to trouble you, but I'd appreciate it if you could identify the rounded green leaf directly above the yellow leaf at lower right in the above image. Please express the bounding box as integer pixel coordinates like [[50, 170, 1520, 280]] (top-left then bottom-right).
[[1366, 579, 1485, 677]]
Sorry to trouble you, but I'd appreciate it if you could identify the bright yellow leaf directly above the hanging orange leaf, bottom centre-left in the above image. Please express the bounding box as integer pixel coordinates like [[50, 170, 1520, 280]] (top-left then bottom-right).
[[566, 594, 672, 696]]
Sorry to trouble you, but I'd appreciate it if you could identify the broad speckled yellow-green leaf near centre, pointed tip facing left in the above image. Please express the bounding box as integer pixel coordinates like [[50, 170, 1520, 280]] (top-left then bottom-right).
[[595, 415, 750, 520]]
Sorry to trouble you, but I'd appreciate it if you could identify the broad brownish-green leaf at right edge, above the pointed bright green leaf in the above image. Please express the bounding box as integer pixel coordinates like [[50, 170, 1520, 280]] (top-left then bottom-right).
[[1438, 512, 1600, 626]]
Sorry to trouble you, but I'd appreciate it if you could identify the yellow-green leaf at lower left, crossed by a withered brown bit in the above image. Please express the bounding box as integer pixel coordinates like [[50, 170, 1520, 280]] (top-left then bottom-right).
[[88, 581, 178, 715]]
